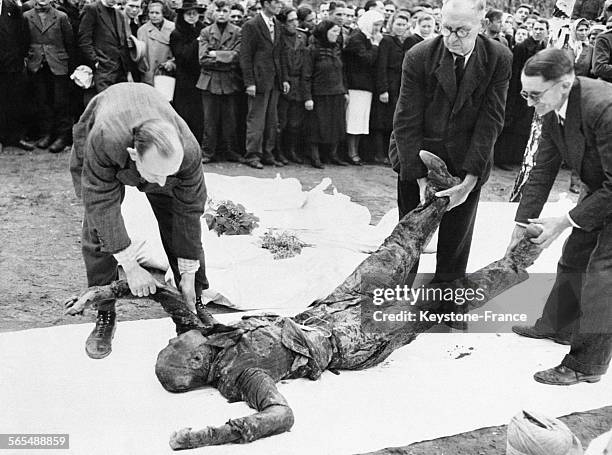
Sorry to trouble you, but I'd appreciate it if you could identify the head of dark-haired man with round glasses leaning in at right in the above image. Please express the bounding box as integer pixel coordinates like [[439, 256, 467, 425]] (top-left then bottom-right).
[[521, 48, 575, 115]]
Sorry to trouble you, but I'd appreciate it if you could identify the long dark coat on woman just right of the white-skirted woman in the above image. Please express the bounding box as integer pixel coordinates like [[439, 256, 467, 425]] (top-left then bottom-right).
[[370, 35, 404, 131]]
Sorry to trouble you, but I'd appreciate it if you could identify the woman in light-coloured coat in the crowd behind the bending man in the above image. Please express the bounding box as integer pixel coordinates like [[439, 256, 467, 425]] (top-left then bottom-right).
[[137, 0, 175, 85]]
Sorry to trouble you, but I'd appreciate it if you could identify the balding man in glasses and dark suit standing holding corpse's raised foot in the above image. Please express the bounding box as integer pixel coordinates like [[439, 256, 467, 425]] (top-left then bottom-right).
[[389, 0, 512, 285]]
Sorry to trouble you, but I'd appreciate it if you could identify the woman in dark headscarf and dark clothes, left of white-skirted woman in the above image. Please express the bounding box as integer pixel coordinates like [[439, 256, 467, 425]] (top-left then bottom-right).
[[302, 20, 347, 169]]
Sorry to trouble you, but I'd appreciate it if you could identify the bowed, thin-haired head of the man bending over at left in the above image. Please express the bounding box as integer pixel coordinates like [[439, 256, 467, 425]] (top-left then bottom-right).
[[127, 119, 184, 186]]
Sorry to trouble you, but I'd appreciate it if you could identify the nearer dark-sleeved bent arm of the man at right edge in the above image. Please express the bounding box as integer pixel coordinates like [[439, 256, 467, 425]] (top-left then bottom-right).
[[569, 107, 612, 232]]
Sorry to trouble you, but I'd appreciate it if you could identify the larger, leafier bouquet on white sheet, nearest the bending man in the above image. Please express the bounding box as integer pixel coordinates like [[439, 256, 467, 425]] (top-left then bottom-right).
[[204, 201, 259, 236]]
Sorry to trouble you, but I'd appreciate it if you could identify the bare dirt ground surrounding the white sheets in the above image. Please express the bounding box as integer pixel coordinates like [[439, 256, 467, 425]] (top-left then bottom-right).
[[0, 148, 612, 454]]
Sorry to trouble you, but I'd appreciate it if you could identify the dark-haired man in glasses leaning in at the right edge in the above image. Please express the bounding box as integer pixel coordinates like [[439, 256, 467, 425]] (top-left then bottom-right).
[[508, 49, 612, 385]]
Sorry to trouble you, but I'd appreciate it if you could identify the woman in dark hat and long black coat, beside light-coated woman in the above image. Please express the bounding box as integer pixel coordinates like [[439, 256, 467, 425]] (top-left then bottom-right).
[[170, 0, 204, 142]]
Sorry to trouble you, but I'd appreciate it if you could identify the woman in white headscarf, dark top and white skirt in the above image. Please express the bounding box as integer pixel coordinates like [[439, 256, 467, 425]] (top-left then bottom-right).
[[344, 9, 385, 165]]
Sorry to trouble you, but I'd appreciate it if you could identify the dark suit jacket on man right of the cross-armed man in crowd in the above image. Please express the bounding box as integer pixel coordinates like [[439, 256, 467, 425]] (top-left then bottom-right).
[[240, 14, 289, 93]]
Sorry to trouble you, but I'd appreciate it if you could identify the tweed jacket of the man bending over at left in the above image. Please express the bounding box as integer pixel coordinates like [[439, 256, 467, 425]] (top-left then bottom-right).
[[70, 82, 206, 260]]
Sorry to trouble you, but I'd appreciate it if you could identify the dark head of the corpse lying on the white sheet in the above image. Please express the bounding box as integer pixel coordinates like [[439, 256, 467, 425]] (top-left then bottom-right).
[[155, 330, 214, 392]]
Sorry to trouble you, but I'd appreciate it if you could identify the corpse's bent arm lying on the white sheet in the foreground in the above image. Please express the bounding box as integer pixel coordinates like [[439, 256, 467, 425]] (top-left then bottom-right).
[[170, 368, 293, 450]]
